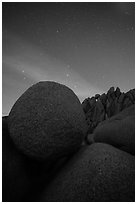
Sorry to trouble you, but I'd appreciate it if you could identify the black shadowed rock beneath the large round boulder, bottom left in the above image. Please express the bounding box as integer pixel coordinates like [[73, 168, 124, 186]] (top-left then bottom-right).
[[2, 117, 67, 202]]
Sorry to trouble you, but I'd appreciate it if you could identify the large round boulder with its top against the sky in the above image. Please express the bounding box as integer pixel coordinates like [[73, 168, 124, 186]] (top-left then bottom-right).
[[8, 81, 87, 160]]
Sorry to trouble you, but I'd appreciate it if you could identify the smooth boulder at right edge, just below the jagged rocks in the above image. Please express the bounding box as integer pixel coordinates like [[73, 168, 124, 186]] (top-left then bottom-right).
[[92, 105, 135, 155]]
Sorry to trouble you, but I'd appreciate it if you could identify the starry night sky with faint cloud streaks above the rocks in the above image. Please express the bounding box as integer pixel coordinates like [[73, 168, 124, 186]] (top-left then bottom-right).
[[2, 2, 135, 115]]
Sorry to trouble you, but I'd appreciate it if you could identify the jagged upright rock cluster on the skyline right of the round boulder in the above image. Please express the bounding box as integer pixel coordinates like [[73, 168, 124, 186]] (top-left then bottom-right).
[[82, 87, 135, 133]]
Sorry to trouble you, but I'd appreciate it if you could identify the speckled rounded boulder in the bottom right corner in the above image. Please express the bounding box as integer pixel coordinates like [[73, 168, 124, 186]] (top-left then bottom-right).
[[41, 143, 135, 202]]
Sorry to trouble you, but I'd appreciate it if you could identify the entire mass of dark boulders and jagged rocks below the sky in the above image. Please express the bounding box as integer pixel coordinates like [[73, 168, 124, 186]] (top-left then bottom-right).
[[2, 81, 135, 202]]
